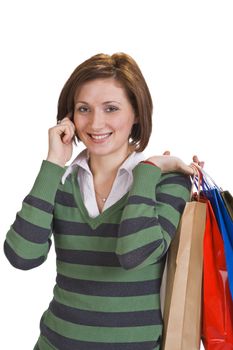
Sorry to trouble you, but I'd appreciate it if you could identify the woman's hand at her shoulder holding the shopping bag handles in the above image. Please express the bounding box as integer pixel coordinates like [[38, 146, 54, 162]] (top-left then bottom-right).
[[147, 151, 204, 175]]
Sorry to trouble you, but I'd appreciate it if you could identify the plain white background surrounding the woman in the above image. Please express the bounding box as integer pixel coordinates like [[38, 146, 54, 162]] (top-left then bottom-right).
[[0, 0, 233, 350]]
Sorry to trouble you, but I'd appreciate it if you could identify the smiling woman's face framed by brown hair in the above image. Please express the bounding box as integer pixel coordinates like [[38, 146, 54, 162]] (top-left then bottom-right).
[[74, 78, 137, 155]]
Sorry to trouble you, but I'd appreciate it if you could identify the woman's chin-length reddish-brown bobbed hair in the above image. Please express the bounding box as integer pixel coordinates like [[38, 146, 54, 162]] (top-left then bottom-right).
[[57, 52, 153, 152]]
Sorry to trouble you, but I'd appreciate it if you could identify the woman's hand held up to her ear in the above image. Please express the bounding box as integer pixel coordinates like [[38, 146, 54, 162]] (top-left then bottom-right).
[[46, 114, 75, 167]]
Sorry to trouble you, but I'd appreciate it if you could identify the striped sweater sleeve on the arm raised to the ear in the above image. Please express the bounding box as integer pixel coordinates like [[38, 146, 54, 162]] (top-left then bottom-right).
[[4, 160, 64, 270]]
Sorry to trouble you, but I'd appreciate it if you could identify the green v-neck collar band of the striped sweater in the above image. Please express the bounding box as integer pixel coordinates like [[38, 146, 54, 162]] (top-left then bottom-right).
[[71, 166, 129, 229]]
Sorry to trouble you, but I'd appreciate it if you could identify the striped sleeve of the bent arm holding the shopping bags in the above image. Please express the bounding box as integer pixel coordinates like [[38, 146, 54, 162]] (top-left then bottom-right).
[[116, 163, 191, 269]]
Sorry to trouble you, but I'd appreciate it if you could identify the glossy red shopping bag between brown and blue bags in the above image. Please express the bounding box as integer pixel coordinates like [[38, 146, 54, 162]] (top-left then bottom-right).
[[202, 198, 233, 350]]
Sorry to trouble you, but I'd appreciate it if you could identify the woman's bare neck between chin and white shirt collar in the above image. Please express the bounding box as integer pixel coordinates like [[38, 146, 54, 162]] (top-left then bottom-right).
[[89, 146, 135, 178]]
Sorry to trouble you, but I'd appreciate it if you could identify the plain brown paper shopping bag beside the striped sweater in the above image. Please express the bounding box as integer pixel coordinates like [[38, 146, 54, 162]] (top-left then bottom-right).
[[162, 201, 206, 350]]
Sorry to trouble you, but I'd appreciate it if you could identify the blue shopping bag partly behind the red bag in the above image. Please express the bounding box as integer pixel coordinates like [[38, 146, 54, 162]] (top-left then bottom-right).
[[203, 170, 233, 300]]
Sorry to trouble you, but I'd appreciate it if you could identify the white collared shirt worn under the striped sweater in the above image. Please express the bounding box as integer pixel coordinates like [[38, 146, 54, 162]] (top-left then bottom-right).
[[62, 148, 145, 217]]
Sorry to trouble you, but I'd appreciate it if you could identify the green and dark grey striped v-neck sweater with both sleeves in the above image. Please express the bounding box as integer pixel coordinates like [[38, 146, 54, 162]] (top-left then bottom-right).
[[4, 161, 191, 350]]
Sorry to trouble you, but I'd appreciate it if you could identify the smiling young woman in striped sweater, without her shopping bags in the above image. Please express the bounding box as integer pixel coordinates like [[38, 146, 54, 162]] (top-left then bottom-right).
[[4, 53, 201, 350]]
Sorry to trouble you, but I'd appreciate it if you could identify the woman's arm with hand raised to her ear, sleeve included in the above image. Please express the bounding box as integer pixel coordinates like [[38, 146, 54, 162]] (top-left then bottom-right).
[[4, 115, 74, 270]]
